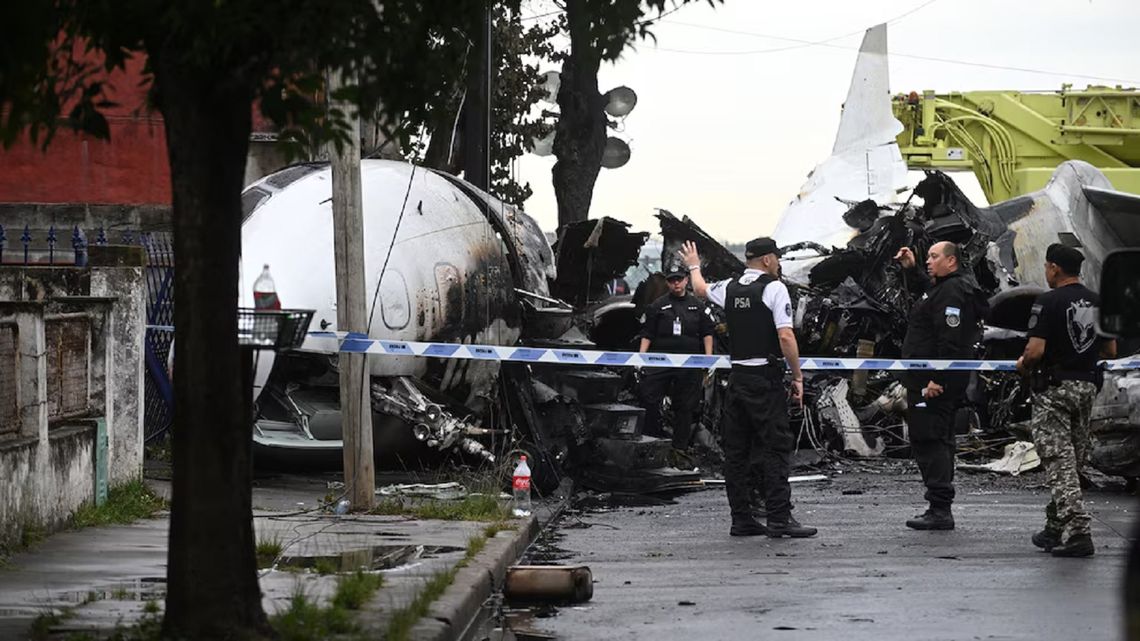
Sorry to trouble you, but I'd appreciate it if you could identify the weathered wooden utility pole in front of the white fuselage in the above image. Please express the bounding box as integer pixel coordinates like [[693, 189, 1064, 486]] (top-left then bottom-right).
[[328, 71, 376, 511]]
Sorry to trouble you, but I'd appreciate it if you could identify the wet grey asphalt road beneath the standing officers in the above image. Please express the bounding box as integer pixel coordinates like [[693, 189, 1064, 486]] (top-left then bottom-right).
[[518, 463, 1135, 641]]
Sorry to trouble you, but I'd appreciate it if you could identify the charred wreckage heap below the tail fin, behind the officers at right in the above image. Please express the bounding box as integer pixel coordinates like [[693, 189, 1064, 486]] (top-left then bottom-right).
[[658, 162, 1140, 477]]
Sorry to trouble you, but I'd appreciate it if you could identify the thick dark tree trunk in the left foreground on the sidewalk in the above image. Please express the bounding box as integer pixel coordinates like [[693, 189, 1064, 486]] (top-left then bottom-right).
[[150, 51, 274, 640]]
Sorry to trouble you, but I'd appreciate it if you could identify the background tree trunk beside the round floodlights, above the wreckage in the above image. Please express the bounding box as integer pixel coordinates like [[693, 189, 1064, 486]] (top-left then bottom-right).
[[552, 0, 606, 227]]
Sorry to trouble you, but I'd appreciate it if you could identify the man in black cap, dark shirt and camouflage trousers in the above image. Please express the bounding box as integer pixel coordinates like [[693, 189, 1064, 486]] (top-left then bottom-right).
[[1017, 243, 1116, 557]]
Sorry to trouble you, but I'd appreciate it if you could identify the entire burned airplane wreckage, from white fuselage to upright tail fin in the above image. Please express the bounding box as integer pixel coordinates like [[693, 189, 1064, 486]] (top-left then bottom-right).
[[241, 19, 1140, 492]]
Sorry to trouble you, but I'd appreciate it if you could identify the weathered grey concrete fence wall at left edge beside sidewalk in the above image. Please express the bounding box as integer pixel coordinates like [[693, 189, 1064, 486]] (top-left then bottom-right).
[[0, 248, 146, 549]]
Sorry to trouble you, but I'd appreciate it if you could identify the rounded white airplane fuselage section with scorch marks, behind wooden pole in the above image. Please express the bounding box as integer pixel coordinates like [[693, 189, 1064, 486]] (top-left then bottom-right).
[[241, 160, 553, 452]]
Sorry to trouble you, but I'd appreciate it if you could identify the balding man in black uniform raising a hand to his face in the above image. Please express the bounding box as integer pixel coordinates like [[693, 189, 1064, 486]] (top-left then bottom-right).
[[895, 242, 986, 529]]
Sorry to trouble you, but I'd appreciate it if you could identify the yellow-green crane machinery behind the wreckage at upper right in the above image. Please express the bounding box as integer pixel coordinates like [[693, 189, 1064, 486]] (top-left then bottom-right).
[[891, 84, 1140, 203]]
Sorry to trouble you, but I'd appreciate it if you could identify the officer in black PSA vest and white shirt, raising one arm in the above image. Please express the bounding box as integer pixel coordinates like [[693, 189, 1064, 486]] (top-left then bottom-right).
[[681, 237, 816, 538]]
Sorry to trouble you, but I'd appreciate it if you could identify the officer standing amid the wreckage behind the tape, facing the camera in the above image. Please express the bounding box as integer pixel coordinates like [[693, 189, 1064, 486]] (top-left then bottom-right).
[[640, 262, 716, 453]]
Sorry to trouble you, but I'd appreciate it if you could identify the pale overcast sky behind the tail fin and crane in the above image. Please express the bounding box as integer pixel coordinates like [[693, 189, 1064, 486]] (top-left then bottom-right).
[[519, 0, 1140, 241]]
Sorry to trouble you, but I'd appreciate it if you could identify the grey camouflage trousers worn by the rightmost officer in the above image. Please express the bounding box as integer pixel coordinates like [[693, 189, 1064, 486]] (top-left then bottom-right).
[[1032, 381, 1097, 541]]
